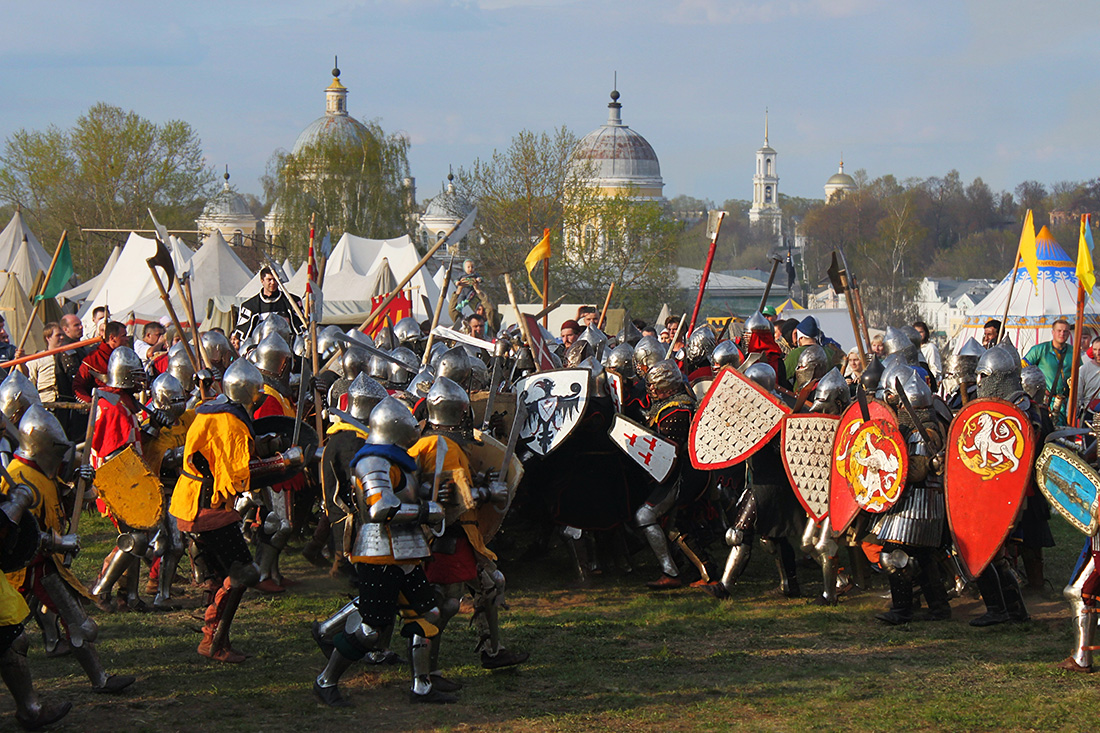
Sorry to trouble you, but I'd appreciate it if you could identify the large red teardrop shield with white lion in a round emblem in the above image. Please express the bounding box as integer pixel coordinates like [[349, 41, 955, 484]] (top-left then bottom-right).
[[944, 398, 1035, 577]]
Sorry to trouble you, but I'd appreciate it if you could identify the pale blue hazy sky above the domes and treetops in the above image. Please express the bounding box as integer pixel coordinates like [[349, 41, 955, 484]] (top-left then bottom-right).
[[0, 0, 1100, 204]]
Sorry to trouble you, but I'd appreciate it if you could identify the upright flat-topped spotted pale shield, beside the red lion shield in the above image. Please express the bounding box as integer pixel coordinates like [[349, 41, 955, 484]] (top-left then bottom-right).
[[780, 414, 840, 522]]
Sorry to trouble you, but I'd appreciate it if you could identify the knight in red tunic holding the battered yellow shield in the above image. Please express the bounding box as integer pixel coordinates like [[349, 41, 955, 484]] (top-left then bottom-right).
[[91, 346, 174, 612]]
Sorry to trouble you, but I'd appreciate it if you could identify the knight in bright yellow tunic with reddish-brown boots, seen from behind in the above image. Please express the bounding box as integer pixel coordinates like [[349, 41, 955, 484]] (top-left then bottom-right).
[[168, 359, 303, 664]]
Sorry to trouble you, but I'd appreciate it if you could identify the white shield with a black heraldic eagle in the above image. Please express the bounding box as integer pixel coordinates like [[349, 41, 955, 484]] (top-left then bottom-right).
[[516, 369, 590, 456]]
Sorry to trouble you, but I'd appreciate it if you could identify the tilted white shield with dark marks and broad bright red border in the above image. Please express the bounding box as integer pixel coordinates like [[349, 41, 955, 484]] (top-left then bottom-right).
[[688, 367, 791, 471]]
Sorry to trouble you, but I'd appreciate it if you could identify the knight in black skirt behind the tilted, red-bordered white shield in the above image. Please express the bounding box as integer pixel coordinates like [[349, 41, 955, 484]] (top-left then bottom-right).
[[706, 362, 805, 598]]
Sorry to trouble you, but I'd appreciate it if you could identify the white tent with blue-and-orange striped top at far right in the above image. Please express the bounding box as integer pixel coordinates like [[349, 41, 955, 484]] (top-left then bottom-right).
[[955, 227, 1100, 354]]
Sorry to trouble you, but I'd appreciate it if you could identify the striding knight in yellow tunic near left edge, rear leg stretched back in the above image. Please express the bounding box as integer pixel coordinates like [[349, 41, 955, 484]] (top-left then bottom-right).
[[4, 405, 134, 694]]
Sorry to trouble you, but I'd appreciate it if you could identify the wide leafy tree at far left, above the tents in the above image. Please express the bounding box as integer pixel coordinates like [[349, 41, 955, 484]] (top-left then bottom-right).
[[0, 102, 215, 274]]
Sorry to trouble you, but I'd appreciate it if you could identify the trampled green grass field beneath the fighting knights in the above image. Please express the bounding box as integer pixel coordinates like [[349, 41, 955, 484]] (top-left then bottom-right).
[[0, 510, 1100, 733]]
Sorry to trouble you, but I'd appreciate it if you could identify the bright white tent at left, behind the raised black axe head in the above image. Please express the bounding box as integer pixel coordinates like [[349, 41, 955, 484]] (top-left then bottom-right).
[[77, 232, 195, 325]]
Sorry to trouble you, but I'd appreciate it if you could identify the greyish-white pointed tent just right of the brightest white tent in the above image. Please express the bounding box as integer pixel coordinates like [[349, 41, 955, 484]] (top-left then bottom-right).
[[127, 229, 252, 324]]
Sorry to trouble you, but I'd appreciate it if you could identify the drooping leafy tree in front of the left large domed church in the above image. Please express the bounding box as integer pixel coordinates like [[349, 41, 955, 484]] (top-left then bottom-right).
[[263, 121, 413, 263]]
